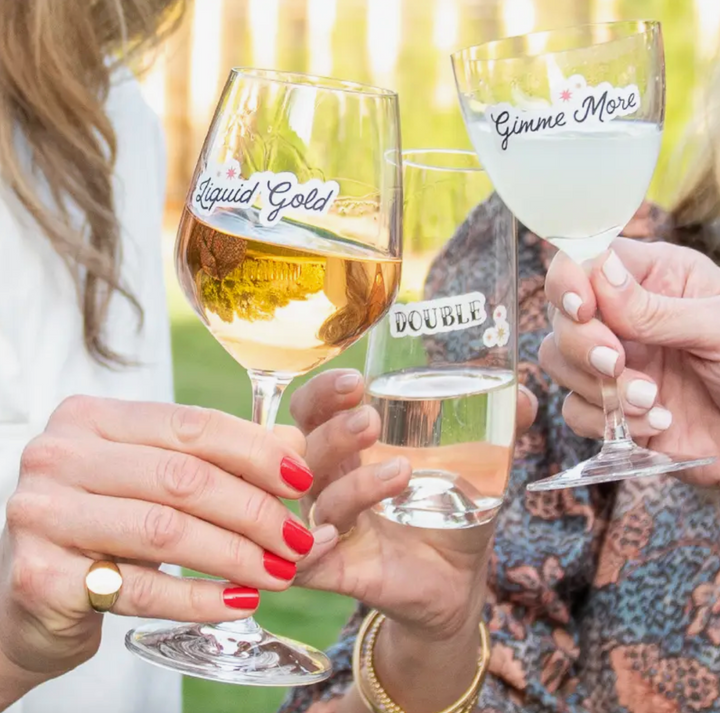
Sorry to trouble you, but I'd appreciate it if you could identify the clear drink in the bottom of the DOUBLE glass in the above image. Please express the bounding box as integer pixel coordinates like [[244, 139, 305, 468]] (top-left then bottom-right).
[[362, 366, 517, 529]]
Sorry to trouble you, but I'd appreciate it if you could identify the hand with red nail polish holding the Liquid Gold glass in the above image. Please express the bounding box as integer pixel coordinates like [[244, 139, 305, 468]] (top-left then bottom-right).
[[0, 397, 313, 708]]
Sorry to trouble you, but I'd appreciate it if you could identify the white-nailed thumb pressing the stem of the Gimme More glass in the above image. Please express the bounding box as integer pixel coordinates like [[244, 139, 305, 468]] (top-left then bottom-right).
[[590, 250, 720, 356]]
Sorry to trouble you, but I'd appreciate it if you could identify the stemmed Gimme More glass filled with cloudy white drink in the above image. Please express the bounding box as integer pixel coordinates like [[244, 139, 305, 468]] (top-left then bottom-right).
[[452, 21, 714, 491]]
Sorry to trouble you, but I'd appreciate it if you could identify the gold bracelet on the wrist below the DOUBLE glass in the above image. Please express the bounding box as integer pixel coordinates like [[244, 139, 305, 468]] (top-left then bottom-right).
[[353, 611, 490, 713]]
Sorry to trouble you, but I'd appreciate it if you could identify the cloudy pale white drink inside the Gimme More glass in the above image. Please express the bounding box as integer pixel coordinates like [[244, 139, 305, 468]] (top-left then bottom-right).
[[468, 120, 662, 262]]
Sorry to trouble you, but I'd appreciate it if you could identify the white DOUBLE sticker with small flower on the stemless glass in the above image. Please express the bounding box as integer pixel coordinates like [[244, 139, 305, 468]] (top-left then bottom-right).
[[388, 292, 510, 348]]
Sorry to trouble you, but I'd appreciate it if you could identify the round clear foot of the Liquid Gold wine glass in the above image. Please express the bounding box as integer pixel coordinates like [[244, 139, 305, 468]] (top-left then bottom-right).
[[125, 619, 332, 686]]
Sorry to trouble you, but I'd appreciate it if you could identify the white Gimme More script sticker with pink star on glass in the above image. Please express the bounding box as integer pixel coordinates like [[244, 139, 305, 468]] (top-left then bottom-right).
[[486, 74, 640, 151]]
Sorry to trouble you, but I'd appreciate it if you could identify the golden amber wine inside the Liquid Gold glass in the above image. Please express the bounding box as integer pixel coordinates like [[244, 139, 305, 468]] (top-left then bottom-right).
[[176, 209, 401, 378]]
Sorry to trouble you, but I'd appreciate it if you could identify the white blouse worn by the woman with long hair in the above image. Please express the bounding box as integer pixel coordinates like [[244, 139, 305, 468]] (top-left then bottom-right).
[[0, 72, 181, 713]]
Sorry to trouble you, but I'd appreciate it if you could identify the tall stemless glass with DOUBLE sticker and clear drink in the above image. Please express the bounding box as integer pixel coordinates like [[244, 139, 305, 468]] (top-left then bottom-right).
[[362, 149, 517, 529]]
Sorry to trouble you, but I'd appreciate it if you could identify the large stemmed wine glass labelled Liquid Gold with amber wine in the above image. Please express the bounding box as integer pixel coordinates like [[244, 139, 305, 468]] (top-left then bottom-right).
[[126, 69, 402, 686]]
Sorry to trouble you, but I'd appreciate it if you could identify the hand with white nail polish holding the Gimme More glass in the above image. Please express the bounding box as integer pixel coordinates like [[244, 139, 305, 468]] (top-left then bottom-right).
[[540, 239, 720, 485]]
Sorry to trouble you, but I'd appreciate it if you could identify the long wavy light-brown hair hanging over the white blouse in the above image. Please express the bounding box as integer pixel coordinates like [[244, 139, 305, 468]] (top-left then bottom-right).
[[0, 0, 184, 365]]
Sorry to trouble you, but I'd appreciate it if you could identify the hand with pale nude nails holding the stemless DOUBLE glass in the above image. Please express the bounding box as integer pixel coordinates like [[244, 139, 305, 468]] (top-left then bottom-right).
[[291, 371, 537, 711]]
